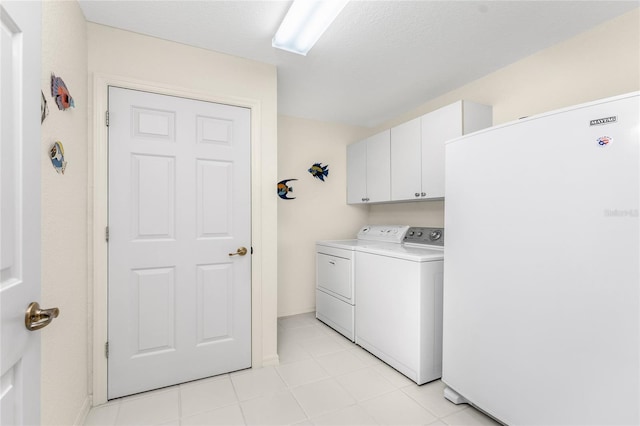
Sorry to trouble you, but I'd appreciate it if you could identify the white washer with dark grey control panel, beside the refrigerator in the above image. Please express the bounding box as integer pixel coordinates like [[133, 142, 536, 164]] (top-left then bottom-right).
[[355, 227, 444, 385]]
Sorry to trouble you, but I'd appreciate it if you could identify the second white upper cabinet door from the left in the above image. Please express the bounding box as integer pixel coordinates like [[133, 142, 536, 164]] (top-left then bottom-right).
[[366, 130, 391, 203]]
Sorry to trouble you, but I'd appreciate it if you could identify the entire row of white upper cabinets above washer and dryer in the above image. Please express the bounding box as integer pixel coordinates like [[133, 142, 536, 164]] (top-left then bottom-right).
[[347, 101, 493, 204]]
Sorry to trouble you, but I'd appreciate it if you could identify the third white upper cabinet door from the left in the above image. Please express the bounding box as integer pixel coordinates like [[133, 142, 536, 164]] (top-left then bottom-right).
[[391, 117, 422, 201]]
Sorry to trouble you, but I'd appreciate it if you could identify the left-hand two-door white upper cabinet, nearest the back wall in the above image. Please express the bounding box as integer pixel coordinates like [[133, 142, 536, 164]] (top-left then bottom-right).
[[347, 130, 391, 204]]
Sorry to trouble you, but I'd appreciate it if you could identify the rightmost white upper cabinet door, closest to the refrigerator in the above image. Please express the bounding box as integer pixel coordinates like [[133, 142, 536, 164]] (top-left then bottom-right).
[[422, 101, 462, 199]]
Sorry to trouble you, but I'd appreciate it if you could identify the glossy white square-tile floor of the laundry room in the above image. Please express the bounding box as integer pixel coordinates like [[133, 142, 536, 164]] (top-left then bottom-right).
[[85, 313, 497, 426]]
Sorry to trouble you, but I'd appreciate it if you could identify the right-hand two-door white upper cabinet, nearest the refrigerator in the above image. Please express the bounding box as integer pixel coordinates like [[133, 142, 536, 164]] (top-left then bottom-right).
[[391, 101, 492, 201]]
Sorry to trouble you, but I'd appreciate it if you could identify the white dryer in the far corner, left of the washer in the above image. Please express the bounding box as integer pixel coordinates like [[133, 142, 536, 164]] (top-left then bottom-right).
[[316, 225, 409, 341]]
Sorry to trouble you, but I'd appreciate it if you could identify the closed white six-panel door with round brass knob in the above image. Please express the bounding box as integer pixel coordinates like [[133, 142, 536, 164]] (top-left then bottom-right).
[[108, 87, 251, 399]]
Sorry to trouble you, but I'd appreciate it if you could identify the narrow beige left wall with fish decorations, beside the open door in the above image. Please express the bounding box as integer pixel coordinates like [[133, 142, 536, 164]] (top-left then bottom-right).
[[41, 1, 89, 425]]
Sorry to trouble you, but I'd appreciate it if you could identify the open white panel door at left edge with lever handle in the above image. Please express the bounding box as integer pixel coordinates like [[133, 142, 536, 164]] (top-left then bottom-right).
[[0, 1, 41, 426]]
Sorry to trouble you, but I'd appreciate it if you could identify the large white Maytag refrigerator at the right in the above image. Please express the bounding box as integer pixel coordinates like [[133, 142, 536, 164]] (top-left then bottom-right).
[[442, 93, 640, 425]]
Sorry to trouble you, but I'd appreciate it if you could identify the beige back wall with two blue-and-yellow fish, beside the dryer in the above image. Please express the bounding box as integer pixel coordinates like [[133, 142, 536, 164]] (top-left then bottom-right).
[[270, 116, 369, 316]]
